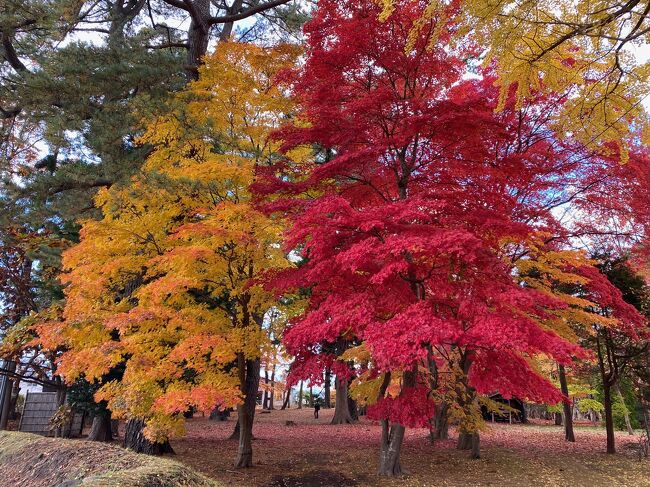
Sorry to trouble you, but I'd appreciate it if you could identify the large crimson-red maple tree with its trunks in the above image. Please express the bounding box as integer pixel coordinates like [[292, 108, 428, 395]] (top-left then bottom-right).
[[261, 0, 644, 475]]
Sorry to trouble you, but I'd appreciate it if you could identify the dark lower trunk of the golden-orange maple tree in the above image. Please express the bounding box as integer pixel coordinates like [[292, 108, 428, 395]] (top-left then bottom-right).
[[235, 354, 260, 468]]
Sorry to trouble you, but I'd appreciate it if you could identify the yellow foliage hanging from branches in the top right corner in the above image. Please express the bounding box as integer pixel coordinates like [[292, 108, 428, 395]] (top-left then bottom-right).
[[375, 0, 650, 163]]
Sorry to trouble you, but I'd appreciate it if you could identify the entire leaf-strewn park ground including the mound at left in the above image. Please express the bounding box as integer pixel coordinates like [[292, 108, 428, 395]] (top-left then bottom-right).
[[0, 408, 650, 487]]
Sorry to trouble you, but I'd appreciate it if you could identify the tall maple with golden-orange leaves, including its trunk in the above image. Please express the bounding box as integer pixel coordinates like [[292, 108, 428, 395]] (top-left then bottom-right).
[[33, 43, 297, 467]]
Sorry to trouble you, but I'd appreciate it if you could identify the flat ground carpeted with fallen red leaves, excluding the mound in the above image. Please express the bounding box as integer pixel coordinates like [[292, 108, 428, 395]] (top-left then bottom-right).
[[172, 409, 650, 487]]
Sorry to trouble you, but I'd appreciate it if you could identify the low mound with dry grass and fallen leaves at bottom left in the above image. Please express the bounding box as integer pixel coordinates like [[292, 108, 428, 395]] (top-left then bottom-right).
[[0, 431, 220, 487]]
